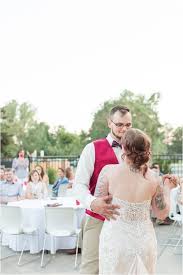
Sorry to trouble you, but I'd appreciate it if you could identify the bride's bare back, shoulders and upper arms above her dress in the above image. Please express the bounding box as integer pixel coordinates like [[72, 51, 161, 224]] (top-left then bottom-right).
[[95, 162, 169, 219]]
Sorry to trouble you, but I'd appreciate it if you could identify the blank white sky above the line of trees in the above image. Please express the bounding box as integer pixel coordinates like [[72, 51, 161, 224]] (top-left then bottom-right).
[[0, 0, 183, 132]]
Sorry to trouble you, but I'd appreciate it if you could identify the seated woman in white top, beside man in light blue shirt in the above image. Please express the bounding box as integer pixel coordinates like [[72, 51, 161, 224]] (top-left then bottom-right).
[[25, 170, 48, 199]]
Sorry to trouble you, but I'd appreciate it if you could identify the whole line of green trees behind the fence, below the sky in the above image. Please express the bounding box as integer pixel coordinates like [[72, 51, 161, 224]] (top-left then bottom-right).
[[1, 90, 177, 158]]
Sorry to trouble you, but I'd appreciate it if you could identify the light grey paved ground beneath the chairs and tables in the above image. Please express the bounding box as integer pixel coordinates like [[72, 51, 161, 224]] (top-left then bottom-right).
[[1, 225, 183, 275]]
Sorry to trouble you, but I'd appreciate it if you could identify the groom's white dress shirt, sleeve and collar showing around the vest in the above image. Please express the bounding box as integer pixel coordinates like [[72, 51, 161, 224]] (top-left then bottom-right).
[[73, 134, 122, 210]]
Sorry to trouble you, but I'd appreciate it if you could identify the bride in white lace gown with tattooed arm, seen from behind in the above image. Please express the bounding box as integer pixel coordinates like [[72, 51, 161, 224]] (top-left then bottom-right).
[[95, 128, 175, 275]]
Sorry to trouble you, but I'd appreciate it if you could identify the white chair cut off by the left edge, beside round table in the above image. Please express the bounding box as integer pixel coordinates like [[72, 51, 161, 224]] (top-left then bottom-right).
[[1, 205, 39, 265]]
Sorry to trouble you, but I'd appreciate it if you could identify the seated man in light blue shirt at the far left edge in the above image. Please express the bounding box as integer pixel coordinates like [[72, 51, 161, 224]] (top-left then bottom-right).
[[0, 168, 23, 203]]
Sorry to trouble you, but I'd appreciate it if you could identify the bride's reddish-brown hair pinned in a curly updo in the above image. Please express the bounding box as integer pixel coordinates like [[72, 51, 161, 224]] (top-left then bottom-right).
[[122, 128, 151, 169]]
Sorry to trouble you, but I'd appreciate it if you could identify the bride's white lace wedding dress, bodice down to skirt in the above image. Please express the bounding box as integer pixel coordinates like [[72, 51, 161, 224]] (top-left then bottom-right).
[[99, 197, 157, 275]]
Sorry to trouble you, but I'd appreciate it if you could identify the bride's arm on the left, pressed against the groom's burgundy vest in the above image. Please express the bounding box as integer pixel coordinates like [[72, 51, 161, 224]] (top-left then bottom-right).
[[94, 165, 109, 197]]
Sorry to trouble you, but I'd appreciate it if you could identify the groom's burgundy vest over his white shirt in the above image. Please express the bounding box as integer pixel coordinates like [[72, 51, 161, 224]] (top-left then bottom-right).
[[86, 138, 119, 220]]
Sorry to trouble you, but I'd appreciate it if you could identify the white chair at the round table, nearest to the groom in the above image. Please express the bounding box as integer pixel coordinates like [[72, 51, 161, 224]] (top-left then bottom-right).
[[41, 207, 81, 267]]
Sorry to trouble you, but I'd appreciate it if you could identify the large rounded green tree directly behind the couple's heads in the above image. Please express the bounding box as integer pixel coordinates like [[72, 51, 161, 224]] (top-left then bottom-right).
[[90, 90, 166, 154]]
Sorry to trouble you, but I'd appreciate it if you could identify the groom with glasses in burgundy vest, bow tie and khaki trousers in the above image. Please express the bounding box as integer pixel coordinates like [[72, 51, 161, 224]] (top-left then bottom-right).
[[74, 105, 132, 274]]
